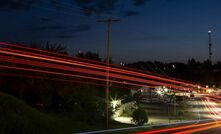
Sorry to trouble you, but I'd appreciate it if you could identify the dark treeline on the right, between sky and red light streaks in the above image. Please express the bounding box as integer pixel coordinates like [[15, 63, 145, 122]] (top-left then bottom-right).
[[126, 58, 221, 87]]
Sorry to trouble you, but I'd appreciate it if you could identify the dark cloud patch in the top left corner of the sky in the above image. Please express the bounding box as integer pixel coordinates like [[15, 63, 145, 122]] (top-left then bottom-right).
[[0, 0, 37, 11]]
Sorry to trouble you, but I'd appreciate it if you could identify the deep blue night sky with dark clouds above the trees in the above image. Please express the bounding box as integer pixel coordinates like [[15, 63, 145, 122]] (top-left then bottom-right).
[[0, 0, 221, 63]]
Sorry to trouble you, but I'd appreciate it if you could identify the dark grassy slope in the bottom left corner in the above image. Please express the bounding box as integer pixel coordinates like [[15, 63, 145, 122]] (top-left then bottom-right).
[[0, 92, 88, 134]]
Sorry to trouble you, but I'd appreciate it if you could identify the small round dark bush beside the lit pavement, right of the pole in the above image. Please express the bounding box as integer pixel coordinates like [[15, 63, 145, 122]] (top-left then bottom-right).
[[132, 108, 148, 126]]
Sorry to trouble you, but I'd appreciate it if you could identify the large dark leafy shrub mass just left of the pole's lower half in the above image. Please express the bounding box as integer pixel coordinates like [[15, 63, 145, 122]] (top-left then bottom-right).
[[57, 85, 113, 124]]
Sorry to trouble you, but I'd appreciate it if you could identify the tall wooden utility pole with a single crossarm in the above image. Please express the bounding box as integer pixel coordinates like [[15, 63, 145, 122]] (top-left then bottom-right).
[[97, 18, 120, 128]]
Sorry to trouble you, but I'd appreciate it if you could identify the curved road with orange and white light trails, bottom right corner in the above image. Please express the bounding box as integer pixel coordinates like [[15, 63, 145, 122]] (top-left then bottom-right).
[[137, 95, 221, 134]]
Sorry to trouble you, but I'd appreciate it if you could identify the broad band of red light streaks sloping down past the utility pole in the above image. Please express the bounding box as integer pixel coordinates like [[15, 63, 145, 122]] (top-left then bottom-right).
[[0, 43, 206, 90]]
